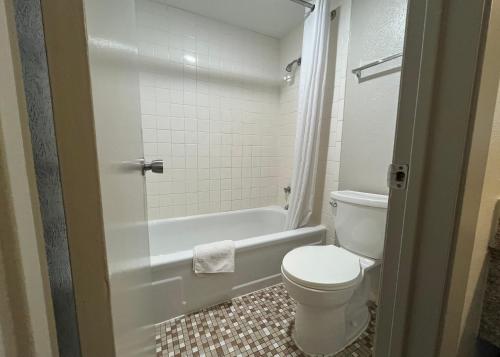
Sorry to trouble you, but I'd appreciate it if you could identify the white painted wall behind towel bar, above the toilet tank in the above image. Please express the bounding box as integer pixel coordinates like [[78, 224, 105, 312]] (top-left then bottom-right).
[[340, 0, 406, 194]]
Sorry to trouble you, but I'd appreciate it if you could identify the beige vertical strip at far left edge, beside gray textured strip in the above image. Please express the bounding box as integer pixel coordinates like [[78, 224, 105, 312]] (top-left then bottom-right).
[[0, 0, 59, 357]]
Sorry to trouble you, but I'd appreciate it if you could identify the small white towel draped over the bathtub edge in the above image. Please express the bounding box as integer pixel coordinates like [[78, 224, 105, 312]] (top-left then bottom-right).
[[193, 240, 234, 274]]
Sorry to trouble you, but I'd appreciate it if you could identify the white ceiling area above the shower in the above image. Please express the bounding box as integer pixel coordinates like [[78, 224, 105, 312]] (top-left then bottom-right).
[[162, 0, 304, 38]]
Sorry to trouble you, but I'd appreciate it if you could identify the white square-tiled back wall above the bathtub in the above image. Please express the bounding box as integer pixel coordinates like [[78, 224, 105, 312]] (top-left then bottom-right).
[[136, 0, 282, 219]]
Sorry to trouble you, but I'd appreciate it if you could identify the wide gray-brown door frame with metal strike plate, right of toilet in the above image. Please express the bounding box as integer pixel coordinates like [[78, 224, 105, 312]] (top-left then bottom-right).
[[375, 0, 490, 357]]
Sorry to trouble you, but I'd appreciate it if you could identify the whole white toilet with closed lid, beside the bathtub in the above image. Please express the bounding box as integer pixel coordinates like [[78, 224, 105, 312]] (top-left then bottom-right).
[[281, 191, 387, 356]]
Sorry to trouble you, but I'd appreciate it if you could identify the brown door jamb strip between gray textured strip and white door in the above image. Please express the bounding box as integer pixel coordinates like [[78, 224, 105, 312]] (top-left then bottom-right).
[[36, 0, 116, 357]]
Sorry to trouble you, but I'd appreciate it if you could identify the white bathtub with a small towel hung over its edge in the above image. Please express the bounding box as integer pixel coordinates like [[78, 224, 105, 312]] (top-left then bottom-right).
[[149, 207, 326, 323]]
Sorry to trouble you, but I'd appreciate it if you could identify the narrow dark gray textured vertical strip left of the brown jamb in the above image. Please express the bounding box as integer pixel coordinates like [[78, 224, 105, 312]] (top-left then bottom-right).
[[14, 0, 80, 357]]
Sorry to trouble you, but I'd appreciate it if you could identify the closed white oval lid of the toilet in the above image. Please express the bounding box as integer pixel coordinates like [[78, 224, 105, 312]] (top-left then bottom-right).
[[282, 245, 362, 290]]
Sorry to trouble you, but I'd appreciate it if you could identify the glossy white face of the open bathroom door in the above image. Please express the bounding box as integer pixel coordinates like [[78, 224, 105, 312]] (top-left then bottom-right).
[[83, 0, 155, 357]]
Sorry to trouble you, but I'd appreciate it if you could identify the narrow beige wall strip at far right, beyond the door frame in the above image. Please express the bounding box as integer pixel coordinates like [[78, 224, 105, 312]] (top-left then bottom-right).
[[440, 2, 500, 357]]
